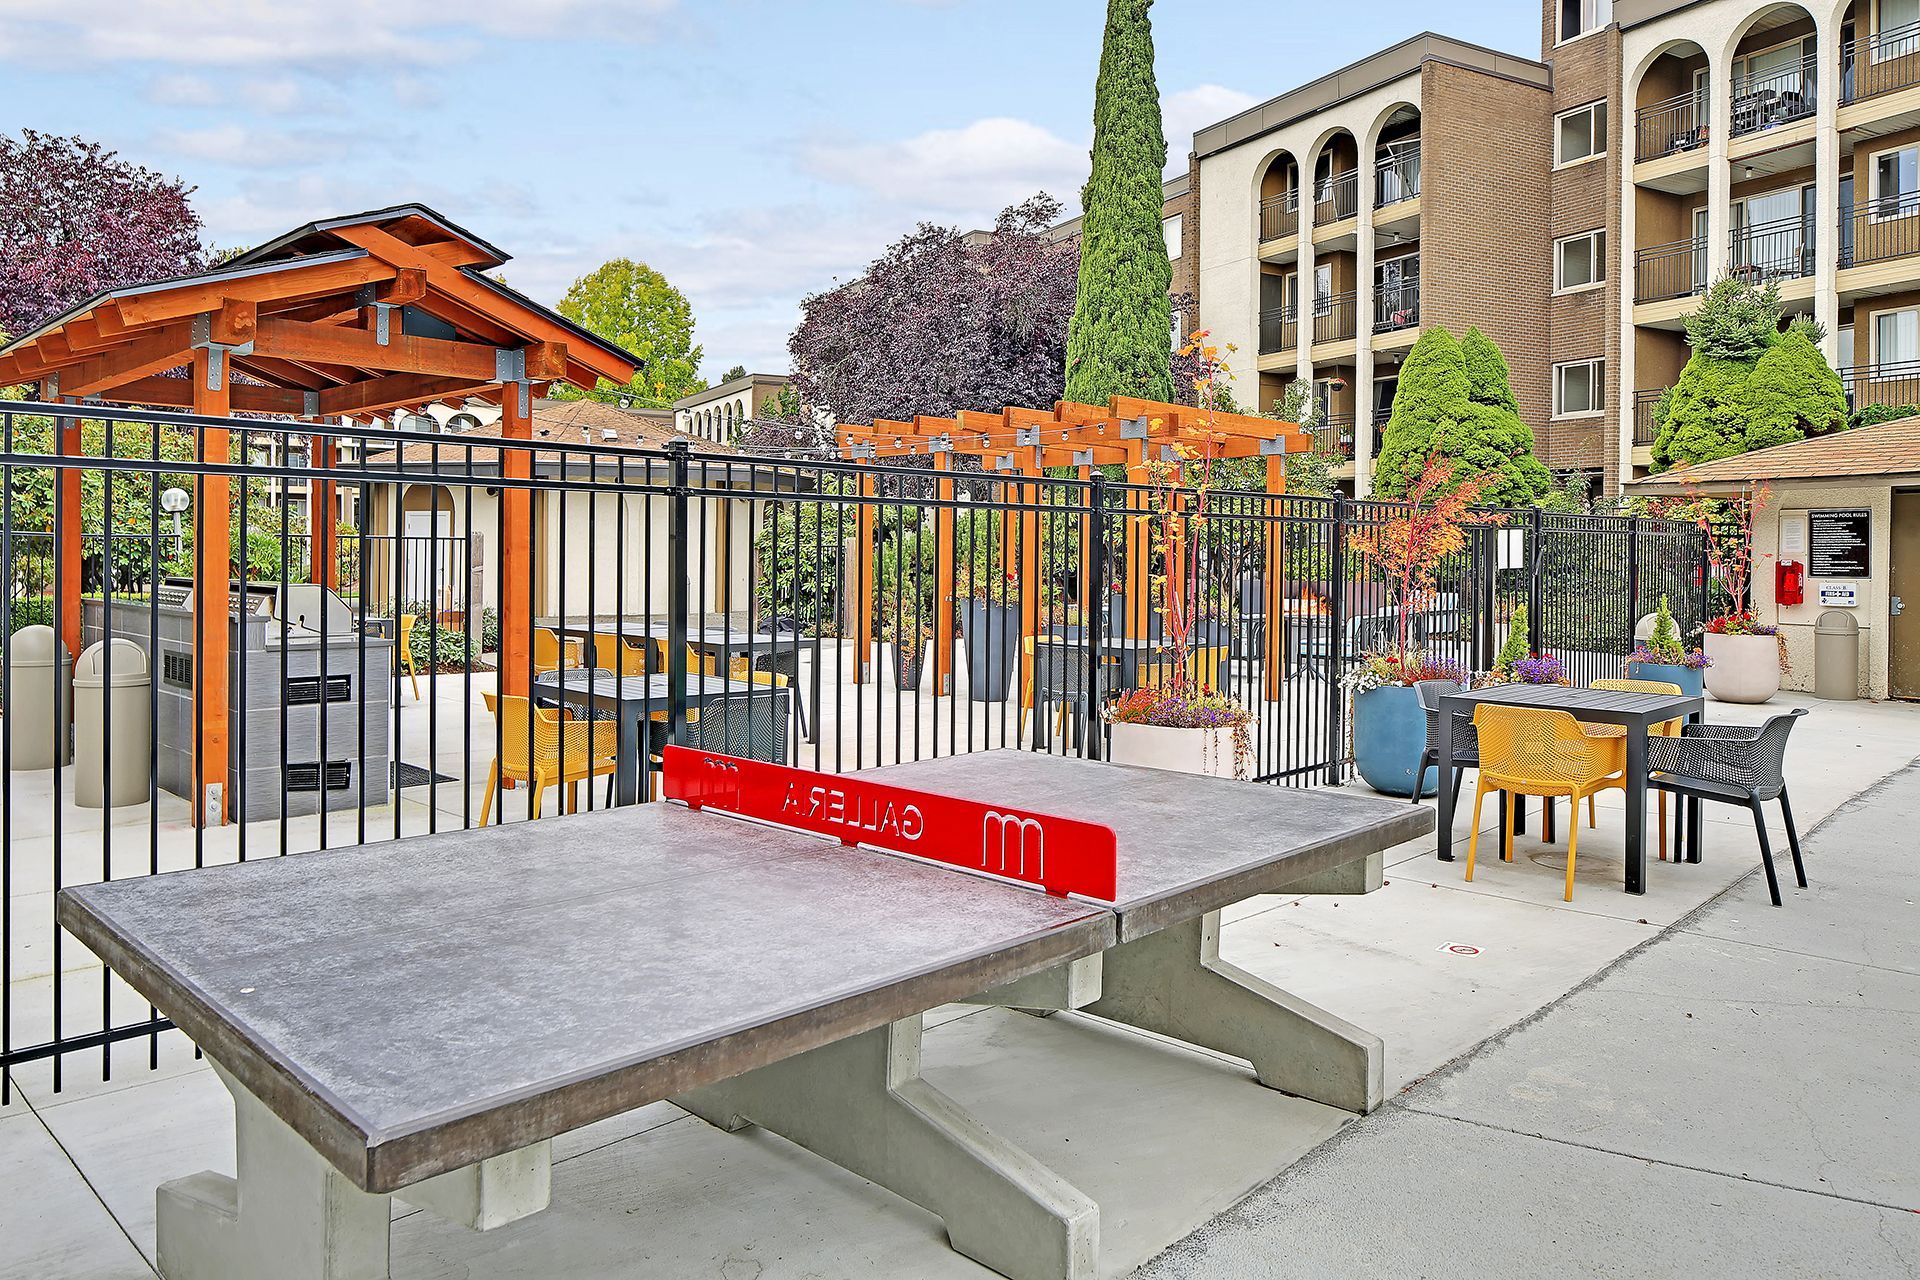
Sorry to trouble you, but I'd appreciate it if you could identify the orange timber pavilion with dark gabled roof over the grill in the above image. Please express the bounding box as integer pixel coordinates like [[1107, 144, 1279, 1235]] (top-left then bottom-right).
[[0, 203, 641, 821]]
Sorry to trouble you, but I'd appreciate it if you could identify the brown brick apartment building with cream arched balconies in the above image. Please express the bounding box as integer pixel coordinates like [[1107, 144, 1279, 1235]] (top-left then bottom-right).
[[1188, 0, 1920, 493]]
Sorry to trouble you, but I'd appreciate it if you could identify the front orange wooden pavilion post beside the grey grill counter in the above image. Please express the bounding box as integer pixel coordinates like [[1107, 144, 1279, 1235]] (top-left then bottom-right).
[[192, 347, 232, 827]]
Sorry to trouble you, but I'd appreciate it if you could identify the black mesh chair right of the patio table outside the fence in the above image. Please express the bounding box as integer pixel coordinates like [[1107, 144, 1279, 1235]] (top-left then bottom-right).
[[1647, 706, 1807, 906]]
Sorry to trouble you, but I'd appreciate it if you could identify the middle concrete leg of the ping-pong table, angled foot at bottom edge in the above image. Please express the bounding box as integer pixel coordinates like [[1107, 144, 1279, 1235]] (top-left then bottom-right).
[[674, 1015, 1100, 1280]]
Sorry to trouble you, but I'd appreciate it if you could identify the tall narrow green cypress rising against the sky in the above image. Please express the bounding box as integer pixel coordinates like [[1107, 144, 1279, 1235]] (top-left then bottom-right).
[[1066, 0, 1173, 405]]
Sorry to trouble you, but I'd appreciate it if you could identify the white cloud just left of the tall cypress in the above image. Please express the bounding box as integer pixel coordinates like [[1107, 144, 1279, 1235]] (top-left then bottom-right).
[[801, 115, 1087, 219]]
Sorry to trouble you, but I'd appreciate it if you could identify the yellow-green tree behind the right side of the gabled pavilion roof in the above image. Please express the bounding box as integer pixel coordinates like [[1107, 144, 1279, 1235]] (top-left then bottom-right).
[[555, 257, 707, 409]]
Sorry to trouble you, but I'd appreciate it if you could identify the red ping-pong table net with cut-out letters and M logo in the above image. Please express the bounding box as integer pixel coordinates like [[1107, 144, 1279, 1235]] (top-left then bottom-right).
[[662, 747, 1117, 902]]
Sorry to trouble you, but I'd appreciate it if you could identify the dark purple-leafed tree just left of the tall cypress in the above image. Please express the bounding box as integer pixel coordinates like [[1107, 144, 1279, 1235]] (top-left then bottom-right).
[[787, 194, 1079, 422]]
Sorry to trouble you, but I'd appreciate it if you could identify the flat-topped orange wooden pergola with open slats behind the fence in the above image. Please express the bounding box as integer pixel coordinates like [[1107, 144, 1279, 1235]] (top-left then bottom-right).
[[837, 395, 1313, 697]]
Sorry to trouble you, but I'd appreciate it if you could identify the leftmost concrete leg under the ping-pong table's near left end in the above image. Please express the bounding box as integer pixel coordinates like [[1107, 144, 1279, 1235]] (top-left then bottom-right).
[[156, 1065, 390, 1280]]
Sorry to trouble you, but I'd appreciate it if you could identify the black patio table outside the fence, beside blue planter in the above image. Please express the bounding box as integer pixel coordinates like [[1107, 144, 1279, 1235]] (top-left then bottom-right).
[[1436, 685, 1707, 894]]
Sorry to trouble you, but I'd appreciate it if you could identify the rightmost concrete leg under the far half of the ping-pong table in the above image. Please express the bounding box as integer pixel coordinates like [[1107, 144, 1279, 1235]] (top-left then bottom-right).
[[1085, 912, 1386, 1113]]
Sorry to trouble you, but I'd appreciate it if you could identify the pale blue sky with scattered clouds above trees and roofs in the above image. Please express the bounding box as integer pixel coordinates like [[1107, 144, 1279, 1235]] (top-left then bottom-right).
[[0, 0, 1540, 378]]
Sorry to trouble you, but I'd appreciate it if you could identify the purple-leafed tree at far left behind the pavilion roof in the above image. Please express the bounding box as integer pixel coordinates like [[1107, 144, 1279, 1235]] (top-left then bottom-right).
[[0, 129, 205, 336]]
